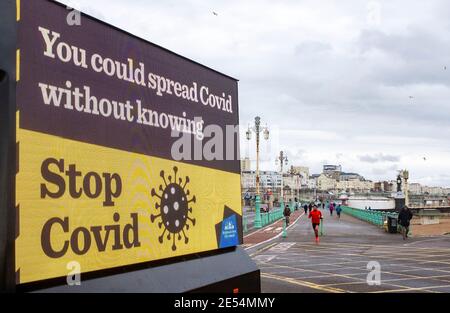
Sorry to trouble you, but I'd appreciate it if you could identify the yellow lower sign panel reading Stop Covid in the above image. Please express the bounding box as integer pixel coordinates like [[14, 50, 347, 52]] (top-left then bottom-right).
[[16, 129, 242, 283]]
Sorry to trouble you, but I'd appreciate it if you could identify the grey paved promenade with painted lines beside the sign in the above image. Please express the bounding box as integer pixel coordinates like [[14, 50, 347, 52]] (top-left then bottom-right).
[[244, 211, 450, 293]]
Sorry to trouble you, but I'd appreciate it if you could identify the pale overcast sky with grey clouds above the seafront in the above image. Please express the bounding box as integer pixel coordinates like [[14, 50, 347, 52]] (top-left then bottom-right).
[[65, 0, 450, 187]]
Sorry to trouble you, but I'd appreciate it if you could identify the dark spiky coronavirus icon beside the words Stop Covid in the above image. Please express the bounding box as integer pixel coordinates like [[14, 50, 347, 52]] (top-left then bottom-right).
[[150, 167, 196, 251]]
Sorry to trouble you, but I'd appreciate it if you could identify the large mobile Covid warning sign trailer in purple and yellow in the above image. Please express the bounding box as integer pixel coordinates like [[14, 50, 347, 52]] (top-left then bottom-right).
[[0, 0, 260, 292]]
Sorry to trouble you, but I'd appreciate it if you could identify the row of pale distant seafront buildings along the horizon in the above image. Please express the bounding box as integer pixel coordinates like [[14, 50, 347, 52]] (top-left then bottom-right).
[[241, 158, 450, 206]]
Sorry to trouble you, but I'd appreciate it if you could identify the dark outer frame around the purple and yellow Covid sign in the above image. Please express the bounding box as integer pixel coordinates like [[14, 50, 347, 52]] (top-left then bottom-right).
[[0, 0, 260, 292]]
